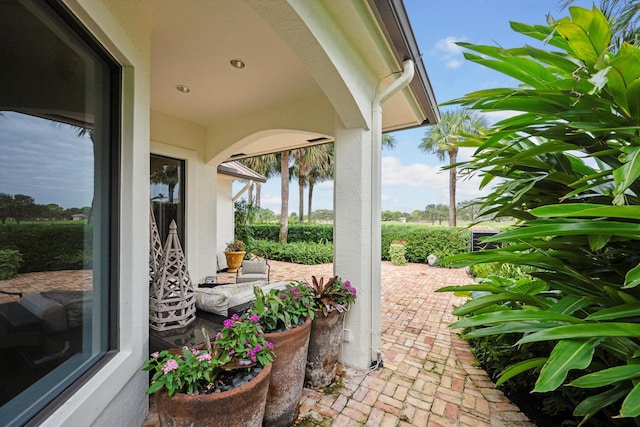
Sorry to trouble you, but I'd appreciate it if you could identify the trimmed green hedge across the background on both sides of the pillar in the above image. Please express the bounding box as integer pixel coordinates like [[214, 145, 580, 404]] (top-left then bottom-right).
[[250, 224, 471, 263]]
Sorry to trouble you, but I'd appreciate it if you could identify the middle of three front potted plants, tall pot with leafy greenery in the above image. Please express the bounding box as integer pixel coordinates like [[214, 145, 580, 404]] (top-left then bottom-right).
[[251, 282, 314, 427]]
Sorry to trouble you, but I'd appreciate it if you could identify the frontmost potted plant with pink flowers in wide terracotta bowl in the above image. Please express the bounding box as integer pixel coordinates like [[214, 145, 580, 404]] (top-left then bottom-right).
[[143, 315, 273, 427]]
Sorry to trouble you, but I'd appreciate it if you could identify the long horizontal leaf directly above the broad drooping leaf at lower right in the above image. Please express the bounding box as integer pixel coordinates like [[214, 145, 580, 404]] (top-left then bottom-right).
[[517, 322, 640, 344]]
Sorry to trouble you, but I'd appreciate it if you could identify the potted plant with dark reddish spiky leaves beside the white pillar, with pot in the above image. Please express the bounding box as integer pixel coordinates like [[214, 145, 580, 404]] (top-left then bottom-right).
[[305, 276, 357, 388]]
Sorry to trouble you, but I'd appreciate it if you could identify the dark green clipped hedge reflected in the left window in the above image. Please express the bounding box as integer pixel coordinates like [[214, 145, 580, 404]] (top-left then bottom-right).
[[0, 221, 92, 273]]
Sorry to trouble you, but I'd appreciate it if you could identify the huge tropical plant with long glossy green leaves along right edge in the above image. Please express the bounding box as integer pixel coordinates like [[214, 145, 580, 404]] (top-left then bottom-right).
[[442, 7, 640, 424]]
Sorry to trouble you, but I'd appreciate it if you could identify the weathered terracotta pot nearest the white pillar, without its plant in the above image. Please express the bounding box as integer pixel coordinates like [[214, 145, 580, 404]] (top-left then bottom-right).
[[305, 311, 346, 388]]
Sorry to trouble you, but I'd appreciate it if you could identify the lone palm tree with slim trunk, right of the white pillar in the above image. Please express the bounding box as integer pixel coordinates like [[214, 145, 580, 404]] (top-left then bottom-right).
[[418, 108, 487, 227]]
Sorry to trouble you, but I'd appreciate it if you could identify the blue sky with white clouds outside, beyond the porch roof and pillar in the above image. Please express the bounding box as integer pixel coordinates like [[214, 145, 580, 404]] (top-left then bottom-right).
[[252, 0, 592, 214]]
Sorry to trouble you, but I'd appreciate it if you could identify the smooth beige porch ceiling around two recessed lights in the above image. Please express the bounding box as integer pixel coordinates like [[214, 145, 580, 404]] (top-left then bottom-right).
[[149, 0, 320, 126]]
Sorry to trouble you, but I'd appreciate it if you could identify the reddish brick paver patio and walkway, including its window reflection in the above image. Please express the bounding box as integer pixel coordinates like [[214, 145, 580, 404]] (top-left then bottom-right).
[[3, 261, 534, 427]]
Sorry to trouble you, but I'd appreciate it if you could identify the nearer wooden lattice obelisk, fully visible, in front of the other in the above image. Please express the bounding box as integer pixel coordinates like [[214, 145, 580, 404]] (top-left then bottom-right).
[[149, 221, 196, 331]]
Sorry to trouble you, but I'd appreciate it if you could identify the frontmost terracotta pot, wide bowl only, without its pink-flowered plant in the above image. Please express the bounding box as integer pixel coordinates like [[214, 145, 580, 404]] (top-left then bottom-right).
[[156, 363, 273, 427]]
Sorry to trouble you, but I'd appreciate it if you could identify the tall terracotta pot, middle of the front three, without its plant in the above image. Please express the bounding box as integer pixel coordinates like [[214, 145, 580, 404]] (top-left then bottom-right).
[[262, 319, 311, 427]]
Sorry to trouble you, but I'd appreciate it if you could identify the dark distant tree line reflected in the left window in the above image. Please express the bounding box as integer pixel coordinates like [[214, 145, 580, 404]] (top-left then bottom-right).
[[0, 193, 91, 224]]
